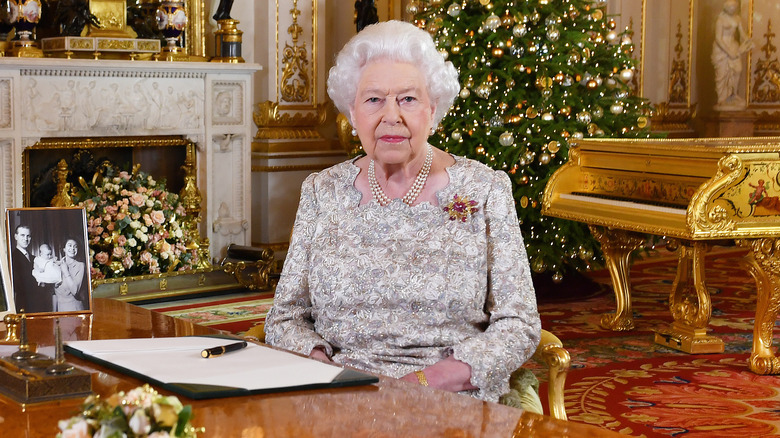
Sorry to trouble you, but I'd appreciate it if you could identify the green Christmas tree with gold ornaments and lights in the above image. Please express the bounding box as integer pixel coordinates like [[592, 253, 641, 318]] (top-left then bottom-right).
[[407, 0, 651, 282]]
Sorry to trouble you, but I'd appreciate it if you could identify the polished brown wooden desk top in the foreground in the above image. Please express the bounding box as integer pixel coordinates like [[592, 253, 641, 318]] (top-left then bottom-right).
[[0, 299, 625, 438]]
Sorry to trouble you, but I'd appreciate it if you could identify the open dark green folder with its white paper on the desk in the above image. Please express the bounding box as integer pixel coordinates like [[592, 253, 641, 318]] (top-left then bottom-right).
[[65, 336, 379, 399]]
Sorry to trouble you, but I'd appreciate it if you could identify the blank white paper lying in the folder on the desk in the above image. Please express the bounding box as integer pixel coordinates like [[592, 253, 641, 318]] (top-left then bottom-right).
[[67, 336, 343, 391]]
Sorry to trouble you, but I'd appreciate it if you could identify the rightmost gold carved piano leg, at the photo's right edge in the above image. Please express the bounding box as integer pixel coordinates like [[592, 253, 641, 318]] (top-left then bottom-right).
[[737, 238, 780, 374]]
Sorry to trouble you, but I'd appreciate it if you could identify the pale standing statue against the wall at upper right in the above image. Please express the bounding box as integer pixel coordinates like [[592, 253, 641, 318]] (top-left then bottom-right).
[[711, 0, 753, 109]]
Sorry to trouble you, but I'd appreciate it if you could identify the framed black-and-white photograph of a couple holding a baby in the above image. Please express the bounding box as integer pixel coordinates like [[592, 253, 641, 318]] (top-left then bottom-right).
[[5, 208, 92, 315]]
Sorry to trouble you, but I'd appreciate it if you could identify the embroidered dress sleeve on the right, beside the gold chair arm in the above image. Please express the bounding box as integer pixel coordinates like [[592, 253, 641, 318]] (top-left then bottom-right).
[[453, 172, 541, 400]]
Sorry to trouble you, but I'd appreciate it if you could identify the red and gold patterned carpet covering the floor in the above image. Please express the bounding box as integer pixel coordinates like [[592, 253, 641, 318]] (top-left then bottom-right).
[[145, 248, 780, 438]]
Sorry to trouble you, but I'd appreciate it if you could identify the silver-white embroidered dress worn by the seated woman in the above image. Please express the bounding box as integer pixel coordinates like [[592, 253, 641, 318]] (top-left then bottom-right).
[[266, 157, 541, 401]]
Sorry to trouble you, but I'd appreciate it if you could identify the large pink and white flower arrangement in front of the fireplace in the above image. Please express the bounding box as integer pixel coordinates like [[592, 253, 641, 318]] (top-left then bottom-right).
[[73, 166, 199, 279]]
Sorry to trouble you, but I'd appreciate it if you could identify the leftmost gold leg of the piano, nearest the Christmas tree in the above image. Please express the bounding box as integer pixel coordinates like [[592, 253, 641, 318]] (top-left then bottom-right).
[[589, 225, 645, 331]]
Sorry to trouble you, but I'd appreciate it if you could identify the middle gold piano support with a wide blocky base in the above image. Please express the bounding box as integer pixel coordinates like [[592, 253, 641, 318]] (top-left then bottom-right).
[[655, 242, 723, 354]]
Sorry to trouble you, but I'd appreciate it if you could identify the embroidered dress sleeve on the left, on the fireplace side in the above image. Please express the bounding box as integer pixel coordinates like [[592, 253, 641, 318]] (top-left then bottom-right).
[[265, 173, 333, 356]]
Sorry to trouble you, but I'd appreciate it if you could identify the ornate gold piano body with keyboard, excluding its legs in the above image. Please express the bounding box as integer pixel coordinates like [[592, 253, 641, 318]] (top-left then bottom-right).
[[542, 137, 780, 240]]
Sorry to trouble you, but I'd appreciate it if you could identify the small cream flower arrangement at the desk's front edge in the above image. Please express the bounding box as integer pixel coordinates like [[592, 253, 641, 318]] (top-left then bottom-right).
[[57, 385, 202, 438]]
